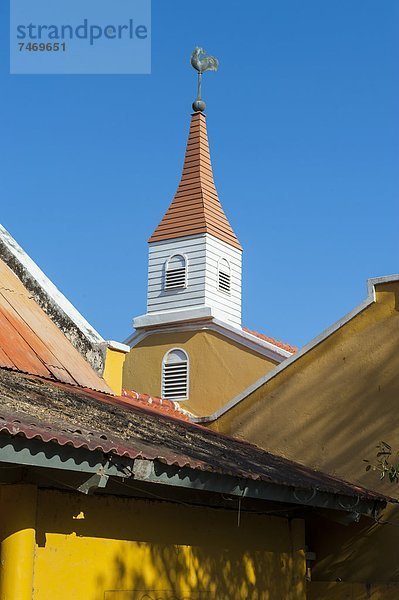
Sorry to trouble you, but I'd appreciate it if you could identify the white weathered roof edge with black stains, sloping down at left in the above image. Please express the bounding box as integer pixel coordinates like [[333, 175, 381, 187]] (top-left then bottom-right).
[[0, 224, 106, 374]]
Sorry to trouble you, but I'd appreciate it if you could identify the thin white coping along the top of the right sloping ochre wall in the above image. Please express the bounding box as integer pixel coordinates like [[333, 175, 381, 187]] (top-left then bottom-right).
[[192, 273, 399, 423]]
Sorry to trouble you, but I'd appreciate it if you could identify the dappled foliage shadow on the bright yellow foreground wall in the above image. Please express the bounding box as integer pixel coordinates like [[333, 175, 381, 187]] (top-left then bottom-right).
[[96, 544, 303, 600]]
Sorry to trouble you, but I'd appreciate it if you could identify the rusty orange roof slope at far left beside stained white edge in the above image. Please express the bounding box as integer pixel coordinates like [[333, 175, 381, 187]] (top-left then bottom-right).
[[0, 260, 112, 393]]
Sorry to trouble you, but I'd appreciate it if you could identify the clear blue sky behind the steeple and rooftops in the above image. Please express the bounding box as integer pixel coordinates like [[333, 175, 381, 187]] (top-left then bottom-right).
[[0, 0, 399, 345]]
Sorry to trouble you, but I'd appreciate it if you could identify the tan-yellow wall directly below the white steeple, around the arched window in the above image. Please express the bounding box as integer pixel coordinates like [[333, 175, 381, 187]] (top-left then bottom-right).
[[123, 330, 276, 416]]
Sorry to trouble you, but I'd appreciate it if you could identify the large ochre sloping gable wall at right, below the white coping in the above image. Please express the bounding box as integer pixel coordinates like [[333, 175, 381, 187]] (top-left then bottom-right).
[[216, 283, 399, 492]]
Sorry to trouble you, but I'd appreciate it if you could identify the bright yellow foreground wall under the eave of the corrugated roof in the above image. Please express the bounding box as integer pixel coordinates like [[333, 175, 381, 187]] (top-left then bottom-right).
[[0, 486, 306, 600]]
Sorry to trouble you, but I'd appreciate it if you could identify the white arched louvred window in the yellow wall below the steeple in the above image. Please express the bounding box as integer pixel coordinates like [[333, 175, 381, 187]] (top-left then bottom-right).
[[162, 348, 188, 400]]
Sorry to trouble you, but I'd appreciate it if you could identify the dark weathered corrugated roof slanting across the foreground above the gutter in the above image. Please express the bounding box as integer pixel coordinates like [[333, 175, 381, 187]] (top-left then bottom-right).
[[0, 369, 387, 500]]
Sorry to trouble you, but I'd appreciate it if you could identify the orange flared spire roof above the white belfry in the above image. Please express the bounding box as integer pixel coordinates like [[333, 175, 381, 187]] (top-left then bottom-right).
[[149, 112, 241, 249]]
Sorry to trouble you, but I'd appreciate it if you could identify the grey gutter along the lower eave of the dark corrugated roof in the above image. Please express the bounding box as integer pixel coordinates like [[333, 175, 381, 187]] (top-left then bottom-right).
[[0, 436, 390, 517]]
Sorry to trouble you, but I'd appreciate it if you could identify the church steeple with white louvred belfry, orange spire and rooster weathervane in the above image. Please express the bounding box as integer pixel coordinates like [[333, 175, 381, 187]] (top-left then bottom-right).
[[133, 48, 242, 330]]
